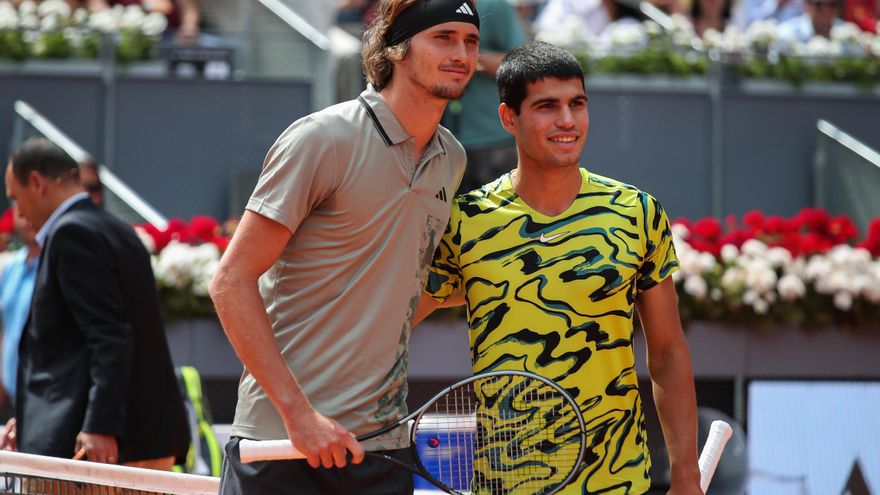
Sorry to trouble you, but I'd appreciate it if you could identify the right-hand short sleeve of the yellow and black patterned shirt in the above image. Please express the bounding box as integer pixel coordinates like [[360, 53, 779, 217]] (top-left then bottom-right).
[[636, 193, 678, 292]]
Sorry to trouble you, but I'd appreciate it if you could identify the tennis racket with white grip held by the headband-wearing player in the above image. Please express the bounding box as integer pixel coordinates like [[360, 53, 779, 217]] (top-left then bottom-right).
[[239, 371, 586, 495]]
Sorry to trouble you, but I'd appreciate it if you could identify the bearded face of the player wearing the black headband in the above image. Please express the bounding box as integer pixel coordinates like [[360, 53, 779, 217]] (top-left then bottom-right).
[[394, 22, 480, 100]]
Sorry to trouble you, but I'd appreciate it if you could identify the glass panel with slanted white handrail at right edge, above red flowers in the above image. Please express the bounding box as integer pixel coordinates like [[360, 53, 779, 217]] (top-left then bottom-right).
[[814, 120, 880, 232]]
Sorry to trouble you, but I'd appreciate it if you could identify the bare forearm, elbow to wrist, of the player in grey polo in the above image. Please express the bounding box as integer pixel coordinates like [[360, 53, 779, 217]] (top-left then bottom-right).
[[211, 273, 311, 411]]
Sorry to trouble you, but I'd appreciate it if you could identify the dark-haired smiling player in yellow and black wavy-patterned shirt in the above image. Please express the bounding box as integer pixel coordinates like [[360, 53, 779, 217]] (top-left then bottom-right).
[[416, 42, 702, 495]]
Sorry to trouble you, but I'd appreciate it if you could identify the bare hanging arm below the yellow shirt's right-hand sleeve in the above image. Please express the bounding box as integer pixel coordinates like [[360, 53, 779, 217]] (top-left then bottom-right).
[[636, 277, 703, 495]]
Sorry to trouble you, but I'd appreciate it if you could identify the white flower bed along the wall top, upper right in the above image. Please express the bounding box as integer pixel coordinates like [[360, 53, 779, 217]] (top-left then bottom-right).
[[542, 14, 880, 89]]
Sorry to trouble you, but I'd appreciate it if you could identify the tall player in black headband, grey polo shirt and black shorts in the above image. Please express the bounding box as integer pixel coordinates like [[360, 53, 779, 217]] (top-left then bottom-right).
[[210, 0, 479, 495]]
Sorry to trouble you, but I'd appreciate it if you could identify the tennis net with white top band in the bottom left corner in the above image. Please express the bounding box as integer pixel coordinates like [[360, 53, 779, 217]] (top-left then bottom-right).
[[0, 451, 219, 495]]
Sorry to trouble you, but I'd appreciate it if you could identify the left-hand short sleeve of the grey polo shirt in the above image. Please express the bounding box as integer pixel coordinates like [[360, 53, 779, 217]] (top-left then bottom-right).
[[246, 116, 339, 232]]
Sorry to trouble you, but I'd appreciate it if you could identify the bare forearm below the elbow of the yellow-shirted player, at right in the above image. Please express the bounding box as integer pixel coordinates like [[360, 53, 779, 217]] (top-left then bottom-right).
[[648, 347, 699, 486]]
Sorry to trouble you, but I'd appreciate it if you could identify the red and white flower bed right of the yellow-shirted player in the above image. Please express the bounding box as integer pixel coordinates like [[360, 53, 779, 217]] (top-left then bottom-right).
[[672, 208, 880, 328]]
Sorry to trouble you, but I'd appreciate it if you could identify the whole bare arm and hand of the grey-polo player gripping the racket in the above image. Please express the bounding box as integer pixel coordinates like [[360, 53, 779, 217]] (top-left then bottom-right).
[[209, 211, 364, 468]]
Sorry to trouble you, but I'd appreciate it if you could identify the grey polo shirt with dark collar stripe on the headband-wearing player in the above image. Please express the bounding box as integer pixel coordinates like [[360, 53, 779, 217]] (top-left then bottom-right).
[[232, 89, 465, 450]]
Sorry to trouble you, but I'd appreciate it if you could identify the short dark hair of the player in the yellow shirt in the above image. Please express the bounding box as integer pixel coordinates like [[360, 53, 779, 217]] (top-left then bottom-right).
[[497, 41, 584, 115]]
